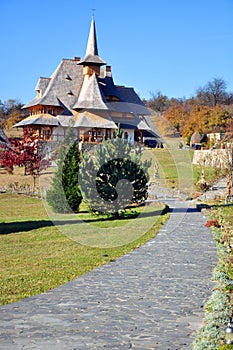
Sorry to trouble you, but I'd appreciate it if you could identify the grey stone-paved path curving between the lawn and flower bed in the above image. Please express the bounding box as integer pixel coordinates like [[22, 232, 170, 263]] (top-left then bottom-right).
[[0, 200, 217, 350]]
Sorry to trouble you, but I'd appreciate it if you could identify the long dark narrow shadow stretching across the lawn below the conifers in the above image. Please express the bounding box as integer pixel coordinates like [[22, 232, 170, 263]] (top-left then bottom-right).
[[0, 207, 169, 235]]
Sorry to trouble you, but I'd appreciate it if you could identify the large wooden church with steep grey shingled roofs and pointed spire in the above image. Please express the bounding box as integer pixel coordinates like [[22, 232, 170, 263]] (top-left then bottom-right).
[[15, 18, 159, 143]]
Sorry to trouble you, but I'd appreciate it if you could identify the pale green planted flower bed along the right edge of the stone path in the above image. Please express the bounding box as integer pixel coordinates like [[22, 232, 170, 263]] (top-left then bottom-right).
[[193, 208, 233, 350]]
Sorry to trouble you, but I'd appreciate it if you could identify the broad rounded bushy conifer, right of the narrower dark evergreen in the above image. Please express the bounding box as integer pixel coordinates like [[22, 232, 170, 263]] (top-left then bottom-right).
[[79, 137, 150, 216]]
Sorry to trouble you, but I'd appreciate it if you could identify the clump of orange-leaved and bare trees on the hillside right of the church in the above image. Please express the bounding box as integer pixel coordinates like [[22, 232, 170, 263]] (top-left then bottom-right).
[[147, 78, 233, 141]]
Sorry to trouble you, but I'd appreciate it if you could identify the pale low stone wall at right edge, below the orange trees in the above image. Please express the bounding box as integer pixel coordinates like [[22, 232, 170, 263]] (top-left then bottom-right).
[[193, 149, 232, 168]]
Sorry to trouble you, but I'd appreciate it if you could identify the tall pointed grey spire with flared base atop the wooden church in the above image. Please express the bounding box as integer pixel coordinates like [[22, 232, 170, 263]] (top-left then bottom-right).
[[78, 17, 106, 67]]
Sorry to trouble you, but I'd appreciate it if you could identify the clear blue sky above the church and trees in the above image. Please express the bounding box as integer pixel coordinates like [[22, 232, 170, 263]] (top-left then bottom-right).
[[0, 0, 233, 103]]
